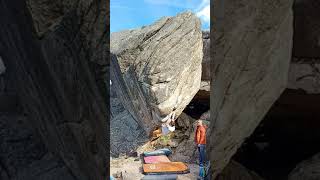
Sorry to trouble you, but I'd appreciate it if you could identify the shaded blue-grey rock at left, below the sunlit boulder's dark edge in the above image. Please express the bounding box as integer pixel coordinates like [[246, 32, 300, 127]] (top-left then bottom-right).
[[110, 54, 148, 156]]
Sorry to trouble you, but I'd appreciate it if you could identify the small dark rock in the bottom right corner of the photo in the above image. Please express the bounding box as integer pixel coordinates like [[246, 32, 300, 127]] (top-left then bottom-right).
[[288, 154, 320, 180]]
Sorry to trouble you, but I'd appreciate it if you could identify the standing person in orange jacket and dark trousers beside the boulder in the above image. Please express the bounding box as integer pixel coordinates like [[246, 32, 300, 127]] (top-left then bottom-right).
[[194, 119, 207, 167]]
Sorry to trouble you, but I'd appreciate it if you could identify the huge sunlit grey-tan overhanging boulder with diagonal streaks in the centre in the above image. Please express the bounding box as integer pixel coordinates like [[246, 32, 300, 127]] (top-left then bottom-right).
[[110, 12, 203, 132]]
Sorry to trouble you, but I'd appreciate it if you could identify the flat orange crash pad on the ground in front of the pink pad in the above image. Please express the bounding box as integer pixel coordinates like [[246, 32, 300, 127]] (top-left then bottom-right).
[[143, 162, 189, 174]]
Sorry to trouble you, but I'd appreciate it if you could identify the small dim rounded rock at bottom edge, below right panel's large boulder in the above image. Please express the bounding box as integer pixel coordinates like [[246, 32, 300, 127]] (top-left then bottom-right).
[[217, 161, 263, 180]]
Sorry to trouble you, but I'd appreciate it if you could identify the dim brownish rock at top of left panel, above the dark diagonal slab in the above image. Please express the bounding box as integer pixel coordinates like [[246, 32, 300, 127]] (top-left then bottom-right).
[[26, 0, 110, 95]]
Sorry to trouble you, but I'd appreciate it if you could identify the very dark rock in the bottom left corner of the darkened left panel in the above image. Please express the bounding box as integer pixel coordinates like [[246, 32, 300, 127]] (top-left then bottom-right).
[[0, 111, 75, 180]]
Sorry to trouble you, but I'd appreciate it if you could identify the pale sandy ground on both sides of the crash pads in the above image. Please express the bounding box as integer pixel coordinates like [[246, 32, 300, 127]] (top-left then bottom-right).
[[110, 157, 199, 180]]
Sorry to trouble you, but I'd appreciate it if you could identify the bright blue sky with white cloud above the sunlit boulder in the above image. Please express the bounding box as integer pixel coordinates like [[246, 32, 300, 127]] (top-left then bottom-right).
[[110, 0, 210, 32]]
